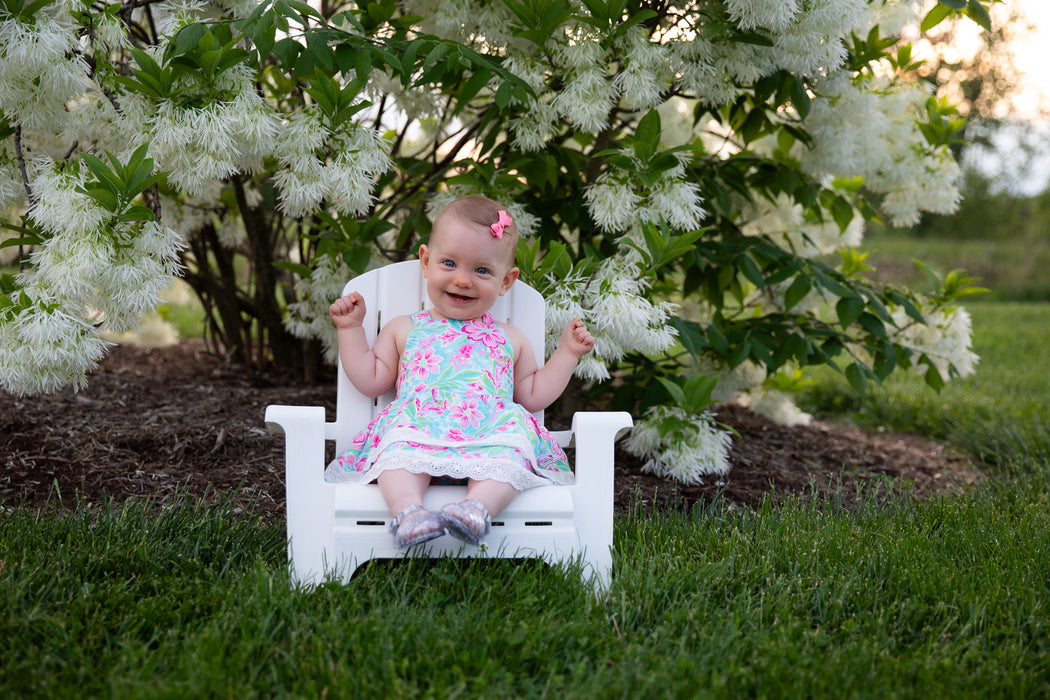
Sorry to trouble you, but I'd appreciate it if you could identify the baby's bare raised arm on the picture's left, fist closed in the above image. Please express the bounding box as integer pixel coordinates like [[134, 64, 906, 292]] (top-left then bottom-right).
[[329, 292, 412, 398]]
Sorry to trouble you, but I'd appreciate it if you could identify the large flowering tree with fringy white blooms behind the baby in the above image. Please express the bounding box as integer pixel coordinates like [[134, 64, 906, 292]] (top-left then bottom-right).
[[0, 0, 989, 482]]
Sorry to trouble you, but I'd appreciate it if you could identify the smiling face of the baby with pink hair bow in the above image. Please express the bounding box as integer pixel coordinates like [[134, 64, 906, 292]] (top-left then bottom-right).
[[419, 216, 518, 320]]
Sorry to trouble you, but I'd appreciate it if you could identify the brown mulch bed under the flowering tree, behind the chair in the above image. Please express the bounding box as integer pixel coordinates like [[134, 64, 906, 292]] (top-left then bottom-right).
[[0, 341, 979, 521]]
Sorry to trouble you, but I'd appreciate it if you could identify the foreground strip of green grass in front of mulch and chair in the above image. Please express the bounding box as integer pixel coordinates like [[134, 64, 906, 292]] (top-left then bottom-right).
[[0, 489, 1050, 698]]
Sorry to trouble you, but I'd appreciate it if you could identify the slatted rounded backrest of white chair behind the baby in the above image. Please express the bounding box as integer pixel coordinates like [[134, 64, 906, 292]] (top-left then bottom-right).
[[331, 260, 546, 451]]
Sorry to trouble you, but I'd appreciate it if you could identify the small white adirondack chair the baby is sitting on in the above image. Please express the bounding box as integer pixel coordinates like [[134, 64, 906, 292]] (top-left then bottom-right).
[[266, 260, 633, 589]]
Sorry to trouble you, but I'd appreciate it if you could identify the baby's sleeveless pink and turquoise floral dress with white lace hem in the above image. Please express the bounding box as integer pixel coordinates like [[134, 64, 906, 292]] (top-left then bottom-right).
[[324, 311, 574, 490]]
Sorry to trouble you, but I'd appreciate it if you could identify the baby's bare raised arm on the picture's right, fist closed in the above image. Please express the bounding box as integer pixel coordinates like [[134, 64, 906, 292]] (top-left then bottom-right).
[[511, 318, 594, 411]]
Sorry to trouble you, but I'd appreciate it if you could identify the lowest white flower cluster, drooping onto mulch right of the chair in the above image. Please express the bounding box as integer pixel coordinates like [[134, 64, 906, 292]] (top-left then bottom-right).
[[624, 406, 732, 484]]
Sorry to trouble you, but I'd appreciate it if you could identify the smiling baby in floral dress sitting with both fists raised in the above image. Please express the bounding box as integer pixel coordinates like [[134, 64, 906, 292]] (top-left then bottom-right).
[[326, 195, 594, 548]]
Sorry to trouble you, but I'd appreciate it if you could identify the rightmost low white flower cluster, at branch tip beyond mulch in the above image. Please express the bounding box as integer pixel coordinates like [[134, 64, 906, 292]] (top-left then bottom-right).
[[893, 304, 979, 381]]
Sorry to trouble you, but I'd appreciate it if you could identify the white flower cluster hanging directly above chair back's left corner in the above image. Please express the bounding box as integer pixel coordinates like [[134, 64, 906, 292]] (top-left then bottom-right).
[[274, 110, 391, 217]]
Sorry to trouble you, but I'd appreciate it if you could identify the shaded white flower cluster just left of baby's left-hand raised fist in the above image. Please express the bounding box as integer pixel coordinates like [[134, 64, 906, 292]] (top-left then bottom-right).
[[285, 255, 353, 363]]
